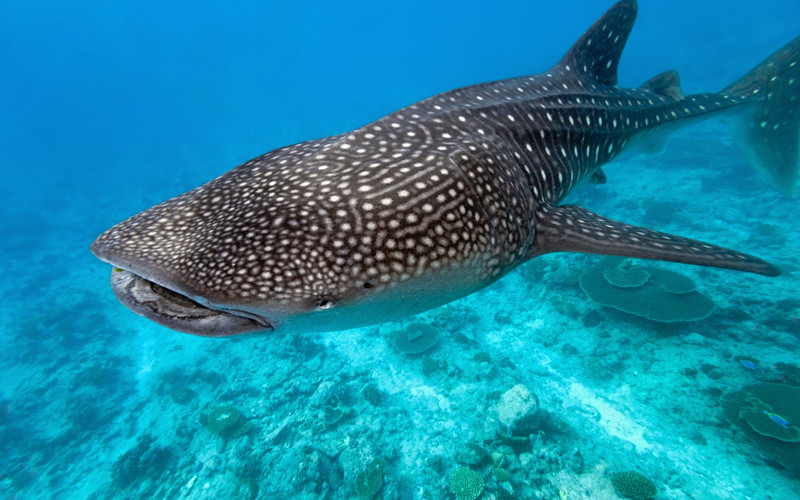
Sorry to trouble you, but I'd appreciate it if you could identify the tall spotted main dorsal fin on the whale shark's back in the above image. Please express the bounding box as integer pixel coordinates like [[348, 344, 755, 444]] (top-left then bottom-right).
[[554, 0, 636, 85]]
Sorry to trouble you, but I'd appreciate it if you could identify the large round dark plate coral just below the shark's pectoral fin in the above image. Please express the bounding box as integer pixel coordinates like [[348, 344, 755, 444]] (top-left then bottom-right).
[[579, 264, 714, 323]]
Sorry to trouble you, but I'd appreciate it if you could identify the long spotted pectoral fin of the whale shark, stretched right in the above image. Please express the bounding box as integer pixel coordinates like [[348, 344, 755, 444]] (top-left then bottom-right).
[[528, 205, 781, 276]]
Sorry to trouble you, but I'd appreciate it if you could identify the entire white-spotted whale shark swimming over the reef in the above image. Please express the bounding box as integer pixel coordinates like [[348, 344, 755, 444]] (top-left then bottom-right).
[[91, 0, 800, 337]]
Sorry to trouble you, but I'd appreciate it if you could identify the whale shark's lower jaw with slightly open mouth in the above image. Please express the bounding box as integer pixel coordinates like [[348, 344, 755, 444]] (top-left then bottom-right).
[[106, 267, 274, 337]]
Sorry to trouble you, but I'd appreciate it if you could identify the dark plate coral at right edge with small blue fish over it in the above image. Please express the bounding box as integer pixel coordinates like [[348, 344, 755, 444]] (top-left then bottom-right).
[[721, 383, 800, 474]]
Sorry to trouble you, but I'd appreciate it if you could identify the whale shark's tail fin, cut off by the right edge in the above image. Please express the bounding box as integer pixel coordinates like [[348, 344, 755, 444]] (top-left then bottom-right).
[[720, 37, 800, 196]]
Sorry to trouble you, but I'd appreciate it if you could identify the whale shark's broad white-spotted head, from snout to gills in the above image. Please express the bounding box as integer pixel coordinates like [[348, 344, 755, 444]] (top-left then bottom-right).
[[91, 135, 512, 336]]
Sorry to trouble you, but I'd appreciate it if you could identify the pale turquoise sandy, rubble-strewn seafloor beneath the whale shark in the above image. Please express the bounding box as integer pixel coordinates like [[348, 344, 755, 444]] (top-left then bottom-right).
[[0, 116, 800, 499]]
